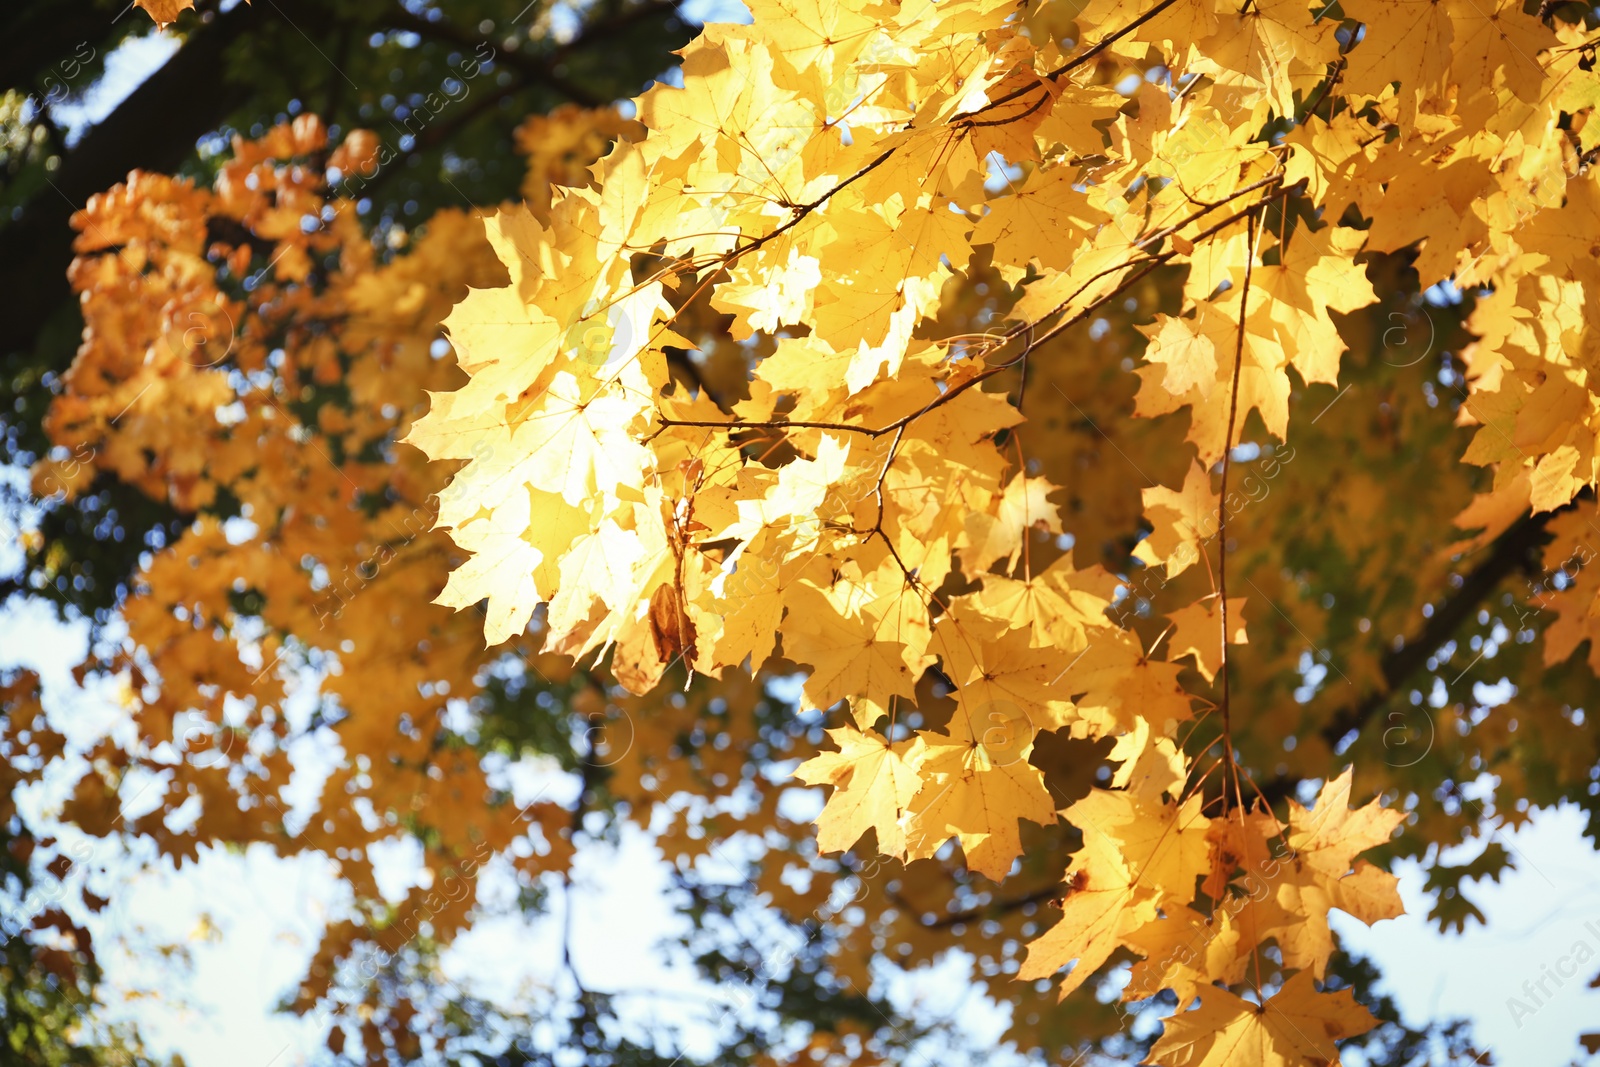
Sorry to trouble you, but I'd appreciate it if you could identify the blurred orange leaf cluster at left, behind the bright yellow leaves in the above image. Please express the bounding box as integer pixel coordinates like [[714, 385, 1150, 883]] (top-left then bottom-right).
[[40, 97, 915, 1062]]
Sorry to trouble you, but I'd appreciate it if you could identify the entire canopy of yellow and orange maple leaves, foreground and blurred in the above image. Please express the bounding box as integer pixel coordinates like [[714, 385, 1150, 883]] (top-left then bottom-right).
[[9, 0, 1600, 1067]]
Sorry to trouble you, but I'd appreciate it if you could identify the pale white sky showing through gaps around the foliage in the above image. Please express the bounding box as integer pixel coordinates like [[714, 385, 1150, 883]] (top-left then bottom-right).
[[9, 12, 1600, 1067]]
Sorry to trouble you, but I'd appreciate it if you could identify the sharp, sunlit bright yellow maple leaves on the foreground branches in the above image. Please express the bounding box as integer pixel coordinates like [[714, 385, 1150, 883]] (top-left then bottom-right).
[[393, 0, 1600, 1062]]
